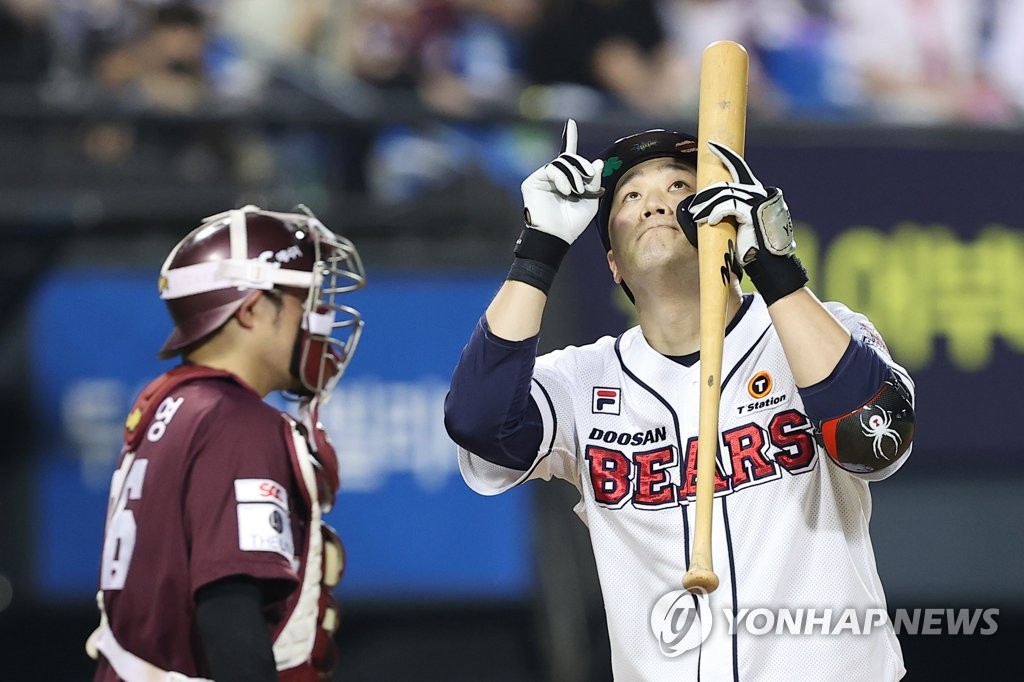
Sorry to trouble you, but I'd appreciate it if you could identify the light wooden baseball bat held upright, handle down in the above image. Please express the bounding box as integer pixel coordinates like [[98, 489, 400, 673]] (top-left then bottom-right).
[[683, 40, 748, 592]]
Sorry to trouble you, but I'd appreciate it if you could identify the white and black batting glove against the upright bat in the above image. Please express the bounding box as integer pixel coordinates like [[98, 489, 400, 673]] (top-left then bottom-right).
[[689, 141, 797, 265]]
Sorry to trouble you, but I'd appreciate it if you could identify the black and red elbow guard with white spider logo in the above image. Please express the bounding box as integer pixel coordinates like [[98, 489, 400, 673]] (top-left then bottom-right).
[[817, 372, 915, 474]]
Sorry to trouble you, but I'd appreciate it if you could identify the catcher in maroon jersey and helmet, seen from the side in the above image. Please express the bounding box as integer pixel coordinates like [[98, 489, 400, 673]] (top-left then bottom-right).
[[86, 206, 365, 682]]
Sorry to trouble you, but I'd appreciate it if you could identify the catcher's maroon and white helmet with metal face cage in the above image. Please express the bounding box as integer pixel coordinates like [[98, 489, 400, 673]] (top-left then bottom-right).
[[159, 206, 366, 395]]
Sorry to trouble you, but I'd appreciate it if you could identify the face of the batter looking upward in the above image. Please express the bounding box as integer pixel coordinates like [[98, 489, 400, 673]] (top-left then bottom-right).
[[608, 158, 696, 282]]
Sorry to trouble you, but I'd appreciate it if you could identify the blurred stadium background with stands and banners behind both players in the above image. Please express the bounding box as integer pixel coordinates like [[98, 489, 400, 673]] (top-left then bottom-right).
[[0, 0, 1024, 682]]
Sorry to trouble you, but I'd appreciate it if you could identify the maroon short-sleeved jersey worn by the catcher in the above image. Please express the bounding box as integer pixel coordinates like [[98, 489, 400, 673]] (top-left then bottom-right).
[[95, 371, 310, 682]]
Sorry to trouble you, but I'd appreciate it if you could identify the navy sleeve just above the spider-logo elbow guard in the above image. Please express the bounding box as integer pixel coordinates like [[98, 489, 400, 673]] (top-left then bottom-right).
[[798, 339, 891, 423]]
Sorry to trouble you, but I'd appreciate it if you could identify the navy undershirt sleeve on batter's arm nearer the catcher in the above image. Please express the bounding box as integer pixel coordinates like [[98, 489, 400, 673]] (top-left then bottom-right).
[[444, 317, 544, 471]]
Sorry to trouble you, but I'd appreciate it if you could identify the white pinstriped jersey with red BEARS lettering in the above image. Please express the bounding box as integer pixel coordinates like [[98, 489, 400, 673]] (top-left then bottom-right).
[[459, 296, 912, 682]]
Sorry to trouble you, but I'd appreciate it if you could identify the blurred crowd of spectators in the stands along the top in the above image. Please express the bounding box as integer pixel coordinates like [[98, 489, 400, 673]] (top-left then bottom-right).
[[0, 0, 1024, 204]]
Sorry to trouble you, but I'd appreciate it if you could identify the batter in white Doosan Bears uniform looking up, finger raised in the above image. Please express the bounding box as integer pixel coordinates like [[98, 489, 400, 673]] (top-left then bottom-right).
[[444, 121, 914, 682]]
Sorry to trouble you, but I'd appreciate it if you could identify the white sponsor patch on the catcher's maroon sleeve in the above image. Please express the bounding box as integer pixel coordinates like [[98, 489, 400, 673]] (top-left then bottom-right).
[[234, 478, 295, 560]]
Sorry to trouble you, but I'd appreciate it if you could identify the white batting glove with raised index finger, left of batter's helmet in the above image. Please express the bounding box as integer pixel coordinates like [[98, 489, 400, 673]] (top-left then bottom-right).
[[521, 119, 604, 244]]
